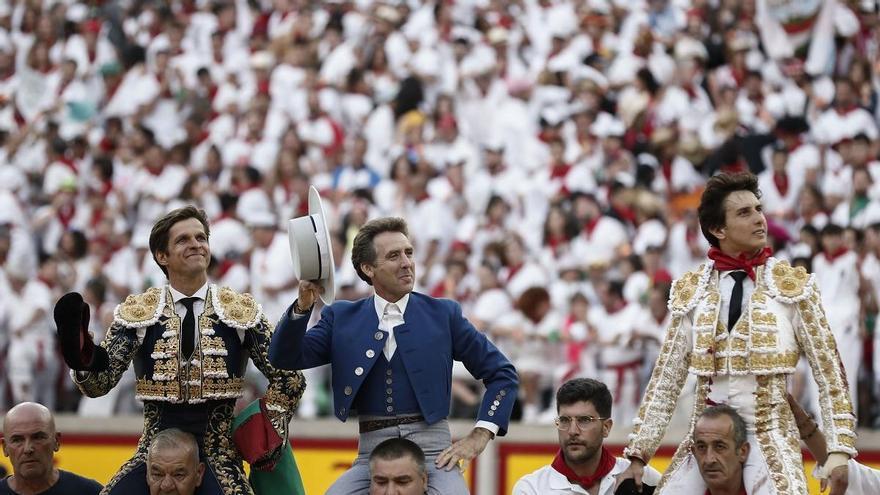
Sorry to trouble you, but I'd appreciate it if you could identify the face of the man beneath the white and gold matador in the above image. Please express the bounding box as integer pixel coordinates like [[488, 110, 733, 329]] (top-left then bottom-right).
[[692, 415, 749, 488]]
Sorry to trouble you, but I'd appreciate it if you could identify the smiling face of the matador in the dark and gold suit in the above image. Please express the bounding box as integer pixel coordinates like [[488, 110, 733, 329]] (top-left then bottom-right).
[[156, 218, 211, 278]]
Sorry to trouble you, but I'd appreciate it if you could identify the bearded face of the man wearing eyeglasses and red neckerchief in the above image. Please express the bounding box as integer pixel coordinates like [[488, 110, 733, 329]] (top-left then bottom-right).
[[559, 401, 613, 467]]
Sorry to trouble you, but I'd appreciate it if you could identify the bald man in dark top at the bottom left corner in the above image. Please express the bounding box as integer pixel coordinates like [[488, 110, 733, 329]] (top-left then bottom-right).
[[0, 402, 102, 495]]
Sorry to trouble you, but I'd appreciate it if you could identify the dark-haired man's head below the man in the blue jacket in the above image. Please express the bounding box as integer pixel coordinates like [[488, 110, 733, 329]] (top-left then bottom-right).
[[370, 438, 428, 495]]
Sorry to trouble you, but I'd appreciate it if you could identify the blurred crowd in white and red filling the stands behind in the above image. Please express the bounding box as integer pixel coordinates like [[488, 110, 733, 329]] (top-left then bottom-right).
[[0, 0, 880, 427]]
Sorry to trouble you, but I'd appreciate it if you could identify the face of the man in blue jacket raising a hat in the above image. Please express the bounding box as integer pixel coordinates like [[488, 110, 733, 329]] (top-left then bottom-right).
[[361, 232, 416, 302]]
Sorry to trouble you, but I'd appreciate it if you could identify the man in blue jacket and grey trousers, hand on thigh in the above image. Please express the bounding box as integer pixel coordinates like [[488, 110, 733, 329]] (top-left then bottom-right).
[[269, 218, 519, 495]]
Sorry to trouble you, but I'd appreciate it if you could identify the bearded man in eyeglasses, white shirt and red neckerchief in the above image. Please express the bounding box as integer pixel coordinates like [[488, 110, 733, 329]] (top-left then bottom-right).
[[513, 378, 660, 495]]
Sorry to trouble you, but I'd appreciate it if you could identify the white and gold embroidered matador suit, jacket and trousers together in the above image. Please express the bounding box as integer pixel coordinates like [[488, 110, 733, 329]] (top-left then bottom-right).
[[624, 257, 856, 495]]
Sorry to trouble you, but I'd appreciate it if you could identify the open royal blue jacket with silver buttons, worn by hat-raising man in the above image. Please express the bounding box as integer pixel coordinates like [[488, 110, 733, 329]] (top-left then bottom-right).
[[269, 292, 519, 435]]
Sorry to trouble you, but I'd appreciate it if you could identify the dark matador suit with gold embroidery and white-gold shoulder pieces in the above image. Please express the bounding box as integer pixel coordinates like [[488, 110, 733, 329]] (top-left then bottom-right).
[[74, 284, 305, 495]]
